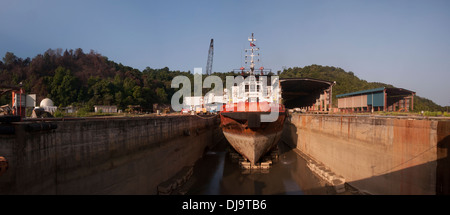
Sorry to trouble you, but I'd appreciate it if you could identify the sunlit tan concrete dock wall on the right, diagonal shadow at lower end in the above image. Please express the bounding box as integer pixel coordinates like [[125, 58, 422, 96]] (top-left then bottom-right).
[[282, 114, 450, 194]]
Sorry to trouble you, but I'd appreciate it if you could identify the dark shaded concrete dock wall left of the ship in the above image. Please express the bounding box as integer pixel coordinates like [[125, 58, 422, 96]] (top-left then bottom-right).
[[0, 116, 219, 194]]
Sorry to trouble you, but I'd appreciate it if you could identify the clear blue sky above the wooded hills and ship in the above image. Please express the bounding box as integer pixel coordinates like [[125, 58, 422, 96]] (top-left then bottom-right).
[[0, 0, 450, 105]]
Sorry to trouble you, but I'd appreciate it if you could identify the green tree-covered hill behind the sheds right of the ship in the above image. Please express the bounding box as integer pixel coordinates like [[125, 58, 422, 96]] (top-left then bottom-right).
[[280, 64, 444, 111]]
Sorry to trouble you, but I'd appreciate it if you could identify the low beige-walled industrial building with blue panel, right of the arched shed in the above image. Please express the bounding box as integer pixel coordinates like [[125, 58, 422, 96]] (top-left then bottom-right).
[[336, 87, 416, 112]]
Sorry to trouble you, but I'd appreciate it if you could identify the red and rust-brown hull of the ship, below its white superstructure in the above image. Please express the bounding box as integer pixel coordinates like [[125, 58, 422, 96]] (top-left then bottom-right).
[[220, 102, 286, 164]]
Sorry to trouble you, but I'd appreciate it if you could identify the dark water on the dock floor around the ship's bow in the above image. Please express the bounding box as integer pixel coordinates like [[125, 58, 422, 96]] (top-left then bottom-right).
[[182, 141, 342, 195]]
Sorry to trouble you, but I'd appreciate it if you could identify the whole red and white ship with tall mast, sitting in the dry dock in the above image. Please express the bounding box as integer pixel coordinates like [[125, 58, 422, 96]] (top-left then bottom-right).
[[220, 33, 286, 164]]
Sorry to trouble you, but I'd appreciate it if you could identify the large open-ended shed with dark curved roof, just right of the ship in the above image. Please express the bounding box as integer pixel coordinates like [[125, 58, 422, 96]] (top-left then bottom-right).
[[280, 78, 336, 111]]
